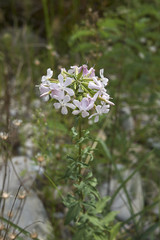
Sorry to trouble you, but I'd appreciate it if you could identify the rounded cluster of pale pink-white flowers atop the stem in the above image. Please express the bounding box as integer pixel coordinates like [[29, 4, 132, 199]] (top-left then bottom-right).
[[39, 65, 114, 122]]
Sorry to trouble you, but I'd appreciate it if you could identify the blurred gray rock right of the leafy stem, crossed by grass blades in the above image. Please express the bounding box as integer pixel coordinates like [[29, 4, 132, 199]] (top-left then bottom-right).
[[100, 167, 144, 221]]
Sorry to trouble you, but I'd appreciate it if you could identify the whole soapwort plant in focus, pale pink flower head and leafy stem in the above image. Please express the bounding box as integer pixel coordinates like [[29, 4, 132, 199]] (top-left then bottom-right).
[[38, 65, 119, 240]]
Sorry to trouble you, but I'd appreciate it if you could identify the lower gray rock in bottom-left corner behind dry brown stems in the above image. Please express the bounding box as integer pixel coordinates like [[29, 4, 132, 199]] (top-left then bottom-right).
[[4, 191, 54, 240]]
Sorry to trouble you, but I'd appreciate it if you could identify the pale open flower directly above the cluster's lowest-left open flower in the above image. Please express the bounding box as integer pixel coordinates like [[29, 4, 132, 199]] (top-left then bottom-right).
[[58, 74, 74, 96]]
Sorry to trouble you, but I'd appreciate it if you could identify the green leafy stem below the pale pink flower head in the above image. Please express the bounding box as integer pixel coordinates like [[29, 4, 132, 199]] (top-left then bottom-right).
[[63, 126, 117, 240]]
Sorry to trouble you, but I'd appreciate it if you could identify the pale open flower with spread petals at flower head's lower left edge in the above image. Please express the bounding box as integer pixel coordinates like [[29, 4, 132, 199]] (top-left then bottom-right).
[[53, 95, 75, 115]]
